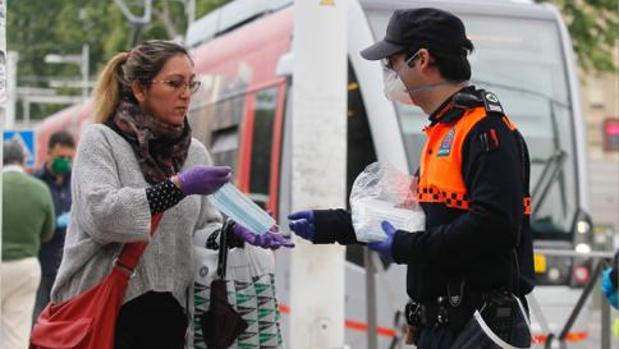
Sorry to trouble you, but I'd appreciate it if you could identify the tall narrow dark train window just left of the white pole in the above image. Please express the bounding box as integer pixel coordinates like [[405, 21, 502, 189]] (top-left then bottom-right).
[[249, 87, 277, 207]]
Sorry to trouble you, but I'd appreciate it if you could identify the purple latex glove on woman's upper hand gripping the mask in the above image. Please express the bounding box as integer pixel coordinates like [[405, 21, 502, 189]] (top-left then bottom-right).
[[177, 165, 232, 195]]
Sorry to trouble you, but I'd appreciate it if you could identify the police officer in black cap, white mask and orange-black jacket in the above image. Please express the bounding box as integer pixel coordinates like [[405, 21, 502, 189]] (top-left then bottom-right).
[[289, 8, 533, 349]]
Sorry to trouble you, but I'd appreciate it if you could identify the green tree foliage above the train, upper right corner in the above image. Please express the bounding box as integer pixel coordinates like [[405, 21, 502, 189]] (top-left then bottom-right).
[[535, 0, 619, 71]]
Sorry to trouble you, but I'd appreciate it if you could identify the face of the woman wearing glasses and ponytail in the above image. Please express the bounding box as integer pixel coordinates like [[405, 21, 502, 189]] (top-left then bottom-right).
[[133, 54, 195, 126]]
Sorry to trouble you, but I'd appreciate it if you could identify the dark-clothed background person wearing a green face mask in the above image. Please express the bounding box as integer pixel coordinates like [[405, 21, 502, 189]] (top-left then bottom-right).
[[33, 130, 75, 320]]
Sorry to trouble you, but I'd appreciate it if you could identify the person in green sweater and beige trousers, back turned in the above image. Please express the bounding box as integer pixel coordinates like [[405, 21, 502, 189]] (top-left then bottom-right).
[[0, 141, 55, 349]]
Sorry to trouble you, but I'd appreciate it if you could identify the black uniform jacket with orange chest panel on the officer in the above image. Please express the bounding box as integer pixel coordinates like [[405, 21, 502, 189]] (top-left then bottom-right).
[[314, 86, 534, 302]]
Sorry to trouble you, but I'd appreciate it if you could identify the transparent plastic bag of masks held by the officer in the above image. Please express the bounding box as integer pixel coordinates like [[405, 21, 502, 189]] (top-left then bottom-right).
[[350, 162, 426, 242]]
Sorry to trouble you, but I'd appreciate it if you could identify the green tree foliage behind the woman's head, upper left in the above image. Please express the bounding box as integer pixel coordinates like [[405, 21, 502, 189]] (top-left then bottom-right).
[[7, 0, 230, 119]]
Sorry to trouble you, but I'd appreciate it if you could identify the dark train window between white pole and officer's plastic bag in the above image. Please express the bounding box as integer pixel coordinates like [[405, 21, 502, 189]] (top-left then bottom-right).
[[346, 64, 376, 266]]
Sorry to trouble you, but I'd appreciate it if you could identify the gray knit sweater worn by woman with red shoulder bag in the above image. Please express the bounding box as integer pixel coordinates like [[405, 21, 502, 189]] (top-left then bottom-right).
[[51, 124, 221, 307]]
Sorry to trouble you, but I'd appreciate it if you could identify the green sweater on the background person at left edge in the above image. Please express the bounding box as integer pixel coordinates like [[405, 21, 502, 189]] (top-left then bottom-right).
[[2, 166, 55, 261]]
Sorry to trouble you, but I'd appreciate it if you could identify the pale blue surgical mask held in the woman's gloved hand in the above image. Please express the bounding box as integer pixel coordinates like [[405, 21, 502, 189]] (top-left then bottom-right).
[[209, 183, 275, 234]]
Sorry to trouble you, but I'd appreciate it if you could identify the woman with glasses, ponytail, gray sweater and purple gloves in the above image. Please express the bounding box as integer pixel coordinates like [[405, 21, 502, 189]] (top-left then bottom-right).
[[51, 41, 288, 349]]
